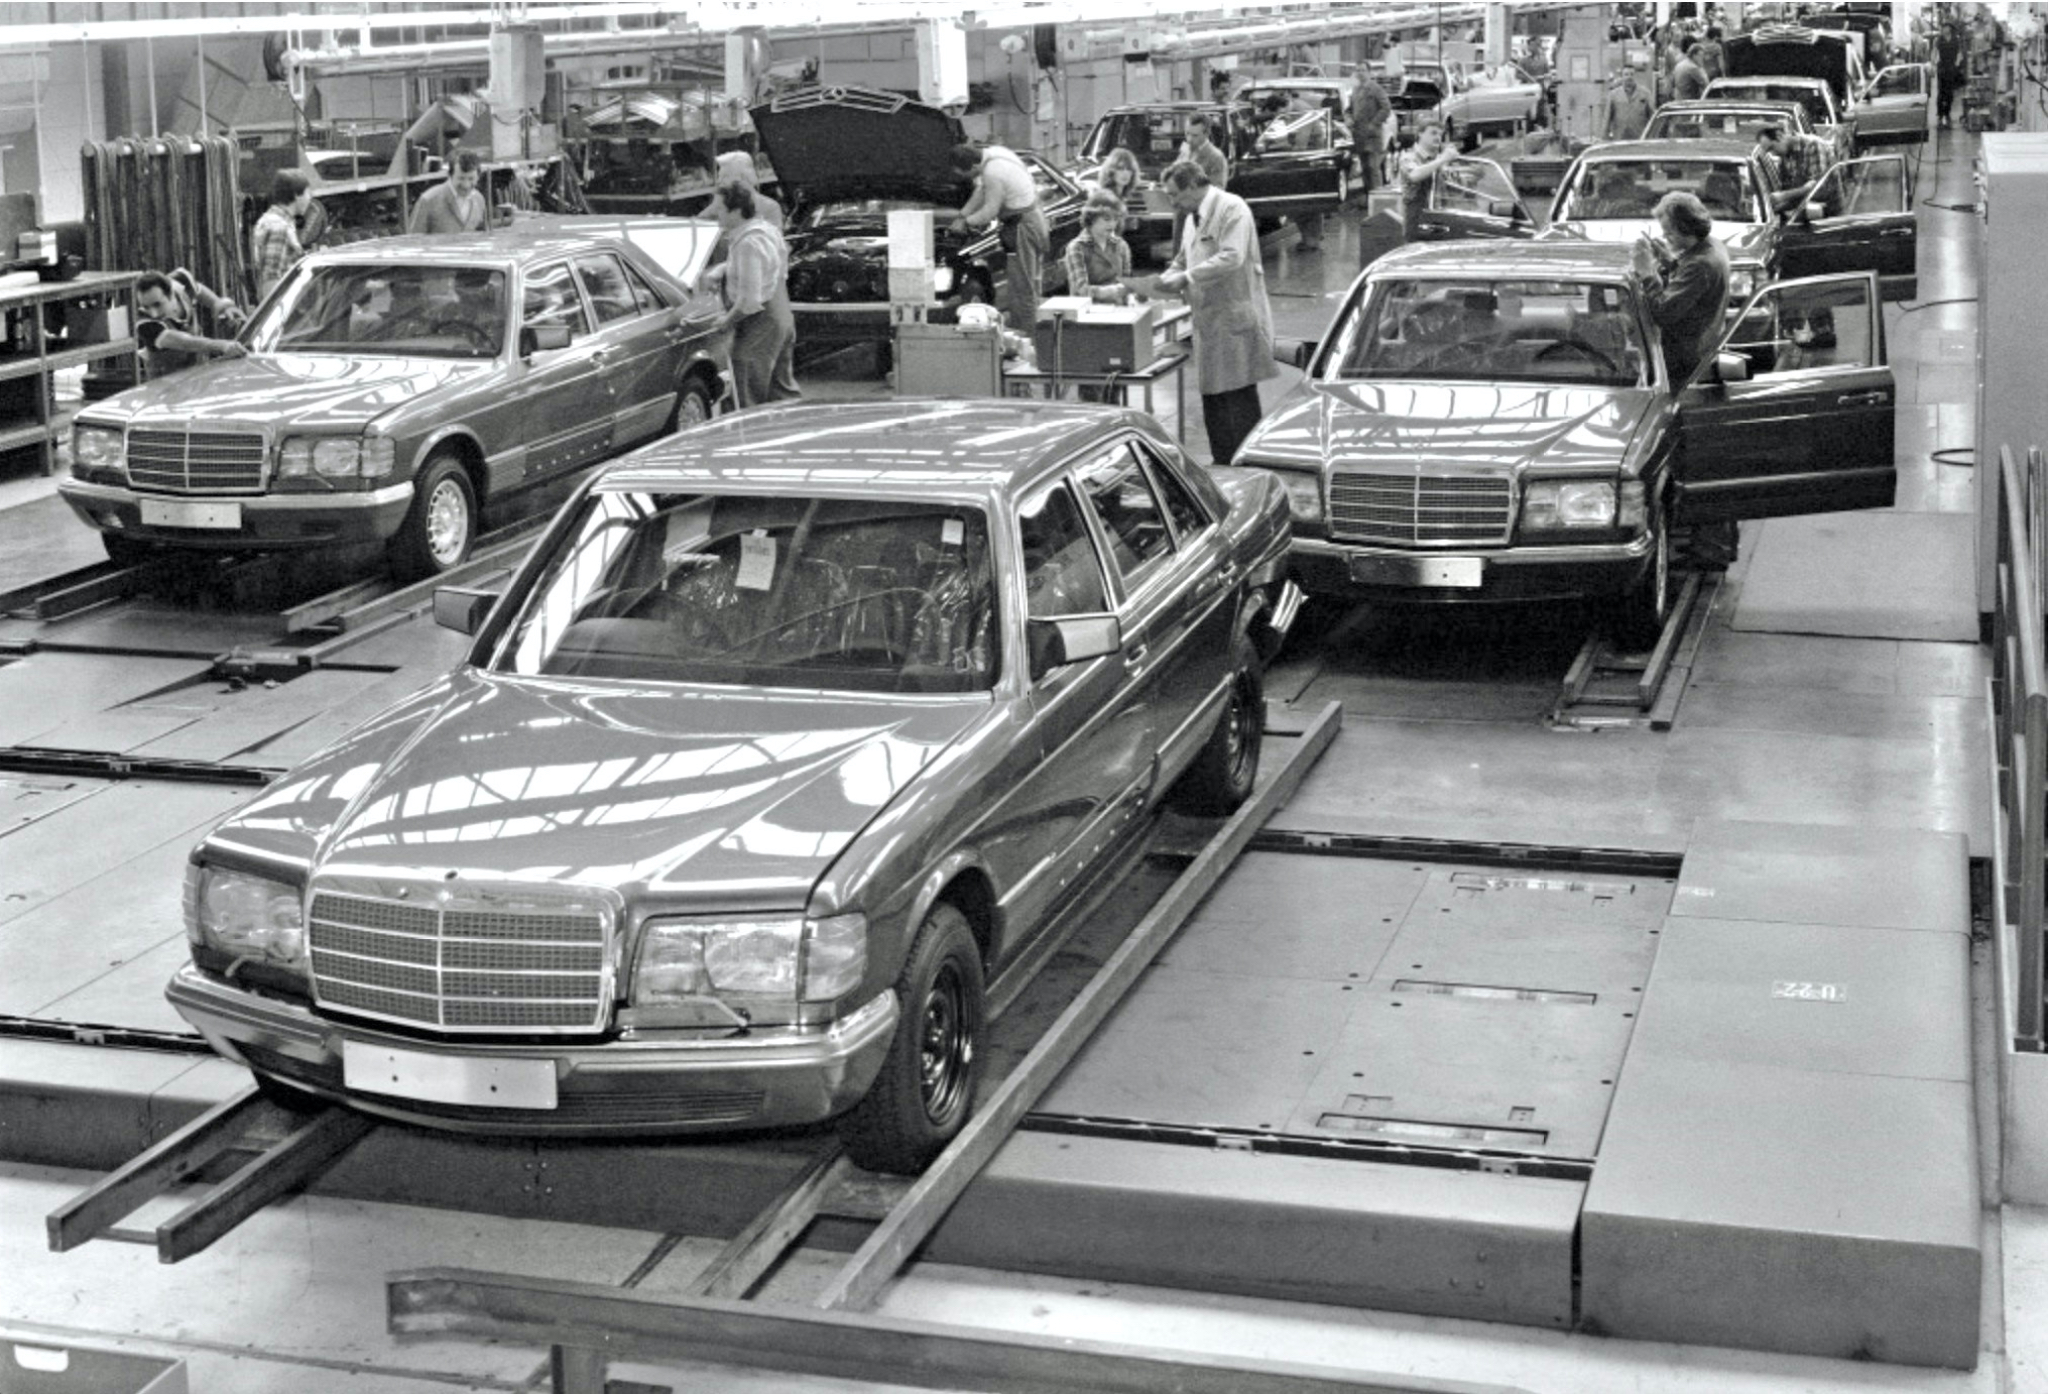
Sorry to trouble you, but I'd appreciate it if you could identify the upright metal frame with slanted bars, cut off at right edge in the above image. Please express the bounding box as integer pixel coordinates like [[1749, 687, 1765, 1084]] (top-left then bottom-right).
[[1991, 446, 2048, 1052]]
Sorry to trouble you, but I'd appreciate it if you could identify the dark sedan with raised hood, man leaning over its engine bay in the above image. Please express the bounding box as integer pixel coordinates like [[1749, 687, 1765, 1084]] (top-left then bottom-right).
[[754, 88, 1083, 346]]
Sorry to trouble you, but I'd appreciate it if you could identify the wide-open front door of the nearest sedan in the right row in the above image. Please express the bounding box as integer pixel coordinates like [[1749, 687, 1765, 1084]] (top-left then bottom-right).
[[1673, 272, 1898, 524]]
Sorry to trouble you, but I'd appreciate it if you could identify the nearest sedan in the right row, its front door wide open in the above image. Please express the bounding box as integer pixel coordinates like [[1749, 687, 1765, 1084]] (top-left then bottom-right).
[[1237, 242, 1896, 639]]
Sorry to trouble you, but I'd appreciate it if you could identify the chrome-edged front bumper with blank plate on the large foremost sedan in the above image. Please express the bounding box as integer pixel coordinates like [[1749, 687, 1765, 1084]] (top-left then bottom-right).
[[178, 964, 897, 1136]]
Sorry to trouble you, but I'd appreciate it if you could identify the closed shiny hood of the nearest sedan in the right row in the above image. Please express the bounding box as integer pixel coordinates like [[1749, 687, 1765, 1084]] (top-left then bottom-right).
[[1241, 381, 1655, 473]]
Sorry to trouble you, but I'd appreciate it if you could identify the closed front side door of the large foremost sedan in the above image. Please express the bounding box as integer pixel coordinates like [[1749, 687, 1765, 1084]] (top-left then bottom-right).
[[979, 473, 1157, 958]]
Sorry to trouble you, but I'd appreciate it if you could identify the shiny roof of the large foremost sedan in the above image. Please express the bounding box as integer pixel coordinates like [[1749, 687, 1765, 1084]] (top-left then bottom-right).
[[604, 397, 1147, 499]]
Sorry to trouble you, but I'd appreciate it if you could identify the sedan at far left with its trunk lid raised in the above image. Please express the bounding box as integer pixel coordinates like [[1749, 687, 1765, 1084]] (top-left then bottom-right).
[[57, 217, 729, 579]]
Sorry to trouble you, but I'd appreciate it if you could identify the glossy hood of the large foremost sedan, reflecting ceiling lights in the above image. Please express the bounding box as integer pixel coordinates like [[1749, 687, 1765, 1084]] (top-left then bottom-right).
[[209, 667, 991, 909]]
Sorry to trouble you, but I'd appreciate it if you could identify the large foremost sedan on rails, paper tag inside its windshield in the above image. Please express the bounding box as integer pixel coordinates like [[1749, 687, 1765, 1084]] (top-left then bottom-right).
[[168, 401, 1300, 1171]]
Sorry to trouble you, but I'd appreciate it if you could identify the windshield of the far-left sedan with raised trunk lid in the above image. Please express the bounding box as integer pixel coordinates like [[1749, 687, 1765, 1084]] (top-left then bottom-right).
[[248, 262, 506, 358]]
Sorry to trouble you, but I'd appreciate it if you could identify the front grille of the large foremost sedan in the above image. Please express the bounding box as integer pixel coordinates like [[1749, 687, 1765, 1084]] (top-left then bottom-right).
[[307, 886, 612, 1032]]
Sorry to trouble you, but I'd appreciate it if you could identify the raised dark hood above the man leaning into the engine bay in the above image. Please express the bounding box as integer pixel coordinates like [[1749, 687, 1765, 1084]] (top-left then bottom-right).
[[754, 90, 967, 207]]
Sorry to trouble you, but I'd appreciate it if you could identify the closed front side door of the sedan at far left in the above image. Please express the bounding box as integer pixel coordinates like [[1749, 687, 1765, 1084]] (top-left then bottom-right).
[[514, 260, 612, 481]]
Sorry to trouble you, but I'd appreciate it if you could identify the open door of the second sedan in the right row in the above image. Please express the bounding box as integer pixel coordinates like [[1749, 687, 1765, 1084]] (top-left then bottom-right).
[[1778, 156, 1919, 301]]
